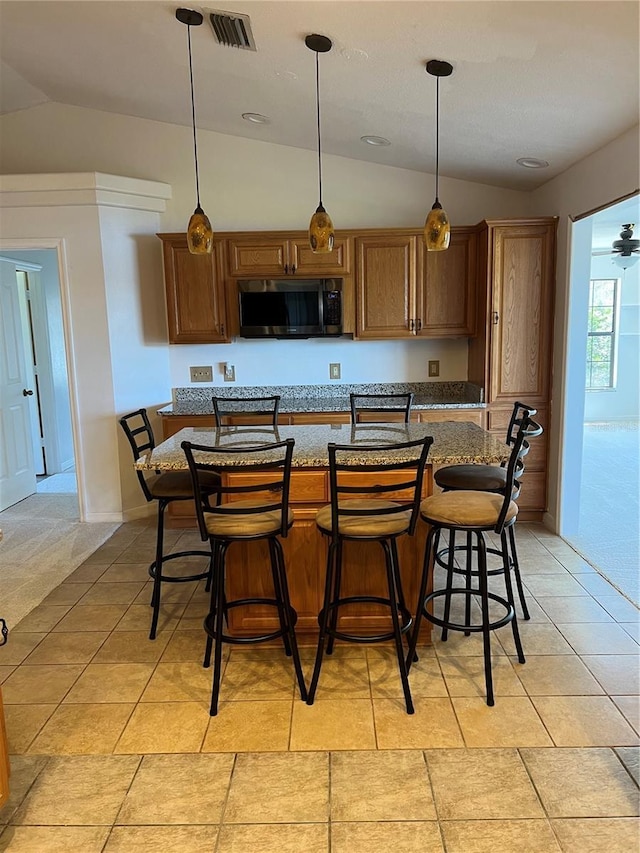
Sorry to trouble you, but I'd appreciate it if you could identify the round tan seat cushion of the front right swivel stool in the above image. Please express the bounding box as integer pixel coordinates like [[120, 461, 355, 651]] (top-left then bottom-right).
[[420, 491, 518, 528]]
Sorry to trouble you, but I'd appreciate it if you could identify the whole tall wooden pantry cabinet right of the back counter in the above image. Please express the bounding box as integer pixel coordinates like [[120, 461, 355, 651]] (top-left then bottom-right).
[[468, 217, 558, 518]]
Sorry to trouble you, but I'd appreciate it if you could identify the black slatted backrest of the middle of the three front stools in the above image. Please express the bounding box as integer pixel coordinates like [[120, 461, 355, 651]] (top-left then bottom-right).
[[328, 436, 433, 540]]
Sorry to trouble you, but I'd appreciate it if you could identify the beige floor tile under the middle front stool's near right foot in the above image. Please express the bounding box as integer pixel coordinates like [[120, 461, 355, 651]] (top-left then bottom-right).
[[373, 697, 464, 749]]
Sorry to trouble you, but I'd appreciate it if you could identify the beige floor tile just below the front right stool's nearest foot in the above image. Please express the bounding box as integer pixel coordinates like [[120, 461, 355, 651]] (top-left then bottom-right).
[[451, 696, 552, 747]]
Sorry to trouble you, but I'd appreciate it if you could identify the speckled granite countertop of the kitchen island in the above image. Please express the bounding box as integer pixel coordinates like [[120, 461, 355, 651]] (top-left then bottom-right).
[[137, 421, 508, 471]]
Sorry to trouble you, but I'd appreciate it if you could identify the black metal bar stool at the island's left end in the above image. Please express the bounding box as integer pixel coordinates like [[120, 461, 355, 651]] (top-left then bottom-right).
[[118, 409, 220, 640]]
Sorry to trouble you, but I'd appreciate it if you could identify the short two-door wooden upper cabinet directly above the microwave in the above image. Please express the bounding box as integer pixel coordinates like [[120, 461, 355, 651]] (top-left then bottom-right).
[[227, 231, 352, 278]]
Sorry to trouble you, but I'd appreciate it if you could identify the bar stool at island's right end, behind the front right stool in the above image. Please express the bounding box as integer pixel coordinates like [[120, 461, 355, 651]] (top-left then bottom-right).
[[433, 402, 543, 619]]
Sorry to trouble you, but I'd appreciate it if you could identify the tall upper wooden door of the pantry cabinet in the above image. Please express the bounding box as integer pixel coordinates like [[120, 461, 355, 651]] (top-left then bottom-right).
[[488, 223, 555, 403]]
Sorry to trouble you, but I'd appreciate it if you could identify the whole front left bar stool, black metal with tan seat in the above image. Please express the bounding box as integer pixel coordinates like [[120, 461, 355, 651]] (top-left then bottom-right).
[[180, 438, 307, 717]]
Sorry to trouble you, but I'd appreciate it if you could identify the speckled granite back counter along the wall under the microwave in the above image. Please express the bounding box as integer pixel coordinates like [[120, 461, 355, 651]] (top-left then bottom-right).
[[158, 382, 484, 415]]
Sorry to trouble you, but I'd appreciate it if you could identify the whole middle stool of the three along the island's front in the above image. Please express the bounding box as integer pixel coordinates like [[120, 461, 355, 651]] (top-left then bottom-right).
[[307, 436, 433, 714]]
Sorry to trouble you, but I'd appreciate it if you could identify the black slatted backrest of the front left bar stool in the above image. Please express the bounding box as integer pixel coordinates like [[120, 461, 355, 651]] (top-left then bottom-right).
[[180, 438, 295, 541]]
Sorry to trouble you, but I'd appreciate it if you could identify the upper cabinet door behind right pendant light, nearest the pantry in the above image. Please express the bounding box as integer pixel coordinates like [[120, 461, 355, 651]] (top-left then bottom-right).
[[419, 231, 477, 337]]
